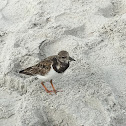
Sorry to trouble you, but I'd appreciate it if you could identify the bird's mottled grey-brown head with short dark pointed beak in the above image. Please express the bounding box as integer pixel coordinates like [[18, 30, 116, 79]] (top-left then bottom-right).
[[58, 50, 75, 64]]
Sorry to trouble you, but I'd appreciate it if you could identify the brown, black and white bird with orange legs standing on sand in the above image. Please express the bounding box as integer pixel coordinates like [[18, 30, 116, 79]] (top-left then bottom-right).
[[19, 50, 75, 94]]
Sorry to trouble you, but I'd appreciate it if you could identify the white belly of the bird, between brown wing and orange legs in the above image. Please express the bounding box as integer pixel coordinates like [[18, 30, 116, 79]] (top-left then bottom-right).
[[37, 66, 60, 81]]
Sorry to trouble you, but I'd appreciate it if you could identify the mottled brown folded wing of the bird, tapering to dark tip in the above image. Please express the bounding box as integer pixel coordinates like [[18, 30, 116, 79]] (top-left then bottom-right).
[[19, 60, 52, 75]]
